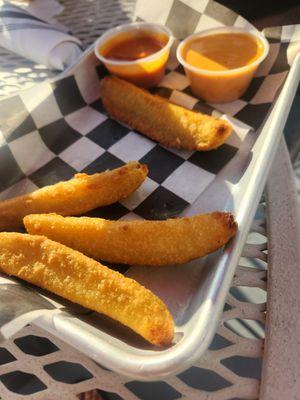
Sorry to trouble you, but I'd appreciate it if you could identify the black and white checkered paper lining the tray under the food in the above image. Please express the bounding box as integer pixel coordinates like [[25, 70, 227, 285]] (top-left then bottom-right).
[[0, 0, 300, 326]]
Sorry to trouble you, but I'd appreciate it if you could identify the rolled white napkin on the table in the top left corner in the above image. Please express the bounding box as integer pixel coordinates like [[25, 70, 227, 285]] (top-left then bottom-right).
[[0, 0, 82, 71]]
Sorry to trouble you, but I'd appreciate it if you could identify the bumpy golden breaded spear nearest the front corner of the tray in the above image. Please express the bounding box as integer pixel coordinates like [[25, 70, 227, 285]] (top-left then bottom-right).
[[0, 232, 174, 346]]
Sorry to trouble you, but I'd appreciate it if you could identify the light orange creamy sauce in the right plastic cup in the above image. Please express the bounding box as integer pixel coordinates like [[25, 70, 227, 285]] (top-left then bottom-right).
[[183, 33, 264, 71]]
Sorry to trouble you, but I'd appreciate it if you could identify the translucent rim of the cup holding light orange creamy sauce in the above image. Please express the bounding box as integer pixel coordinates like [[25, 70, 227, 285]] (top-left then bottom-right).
[[176, 26, 270, 76]]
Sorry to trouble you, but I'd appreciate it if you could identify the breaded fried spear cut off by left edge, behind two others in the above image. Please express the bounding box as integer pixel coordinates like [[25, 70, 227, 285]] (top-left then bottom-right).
[[0, 161, 148, 231]]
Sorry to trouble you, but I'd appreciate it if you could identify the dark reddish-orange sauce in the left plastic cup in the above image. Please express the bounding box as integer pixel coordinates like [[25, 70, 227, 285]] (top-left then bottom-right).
[[100, 32, 168, 61]]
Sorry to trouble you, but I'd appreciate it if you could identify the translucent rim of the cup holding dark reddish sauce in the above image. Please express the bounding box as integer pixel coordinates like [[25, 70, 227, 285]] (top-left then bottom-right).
[[94, 22, 174, 66]]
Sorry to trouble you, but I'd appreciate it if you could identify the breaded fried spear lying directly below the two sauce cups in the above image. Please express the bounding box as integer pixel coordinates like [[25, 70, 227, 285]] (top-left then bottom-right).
[[101, 76, 232, 151]]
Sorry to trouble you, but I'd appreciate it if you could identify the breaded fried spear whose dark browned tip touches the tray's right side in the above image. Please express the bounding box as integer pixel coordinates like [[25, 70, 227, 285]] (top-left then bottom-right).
[[24, 211, 237, 265]]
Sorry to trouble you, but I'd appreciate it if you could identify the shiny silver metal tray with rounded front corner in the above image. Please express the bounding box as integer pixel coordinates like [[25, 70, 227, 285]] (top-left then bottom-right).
[[26, 55, 300, 380]]
